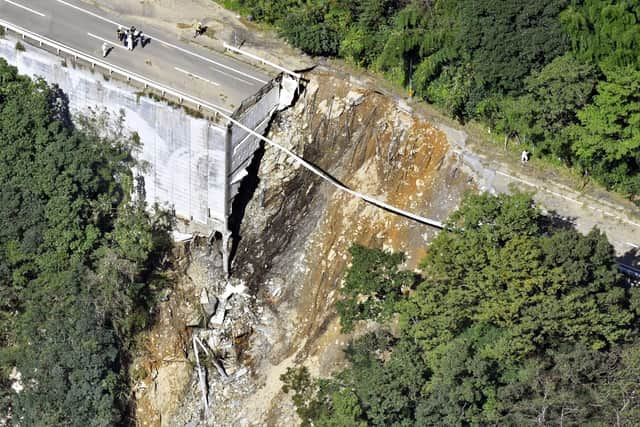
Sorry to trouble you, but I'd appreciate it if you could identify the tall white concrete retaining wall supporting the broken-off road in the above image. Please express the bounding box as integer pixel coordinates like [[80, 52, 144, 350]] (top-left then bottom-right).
[[0, 38, 279, 233]]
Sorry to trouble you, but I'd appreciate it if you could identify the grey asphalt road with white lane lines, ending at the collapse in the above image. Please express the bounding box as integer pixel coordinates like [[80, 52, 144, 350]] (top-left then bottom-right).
[[0, 0, 272, 113]]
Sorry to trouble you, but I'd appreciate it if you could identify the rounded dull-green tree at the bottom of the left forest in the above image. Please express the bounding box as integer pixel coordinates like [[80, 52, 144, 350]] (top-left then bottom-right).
[[13, 271, 125, 426]]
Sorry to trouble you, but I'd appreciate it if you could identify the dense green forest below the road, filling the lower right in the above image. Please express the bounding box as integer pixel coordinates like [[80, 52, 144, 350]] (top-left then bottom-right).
[[281, 193, 640, 427]]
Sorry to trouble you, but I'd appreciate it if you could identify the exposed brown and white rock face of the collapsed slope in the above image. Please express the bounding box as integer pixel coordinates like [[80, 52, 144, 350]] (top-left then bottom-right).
[[130, 69, 471, 426]]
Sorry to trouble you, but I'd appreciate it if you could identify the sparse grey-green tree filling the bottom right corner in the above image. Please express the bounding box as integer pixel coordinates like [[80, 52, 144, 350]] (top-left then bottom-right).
[[499, 343, 640, 425]]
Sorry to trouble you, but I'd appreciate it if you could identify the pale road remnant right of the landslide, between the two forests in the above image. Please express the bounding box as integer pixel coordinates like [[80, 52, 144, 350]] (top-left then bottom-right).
[[432, 118, 640, 264]]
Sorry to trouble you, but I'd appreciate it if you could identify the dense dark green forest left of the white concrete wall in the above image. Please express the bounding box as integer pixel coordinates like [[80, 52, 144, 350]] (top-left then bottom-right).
[[0, 59, 170, 427]]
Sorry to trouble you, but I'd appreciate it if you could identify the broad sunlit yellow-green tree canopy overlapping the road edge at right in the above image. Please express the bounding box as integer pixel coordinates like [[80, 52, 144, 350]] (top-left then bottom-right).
[[400, 194, 634, 360]]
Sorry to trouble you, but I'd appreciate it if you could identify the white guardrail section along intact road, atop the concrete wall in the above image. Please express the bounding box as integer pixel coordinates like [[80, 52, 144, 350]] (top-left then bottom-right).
[[0, 19, 228, 119]]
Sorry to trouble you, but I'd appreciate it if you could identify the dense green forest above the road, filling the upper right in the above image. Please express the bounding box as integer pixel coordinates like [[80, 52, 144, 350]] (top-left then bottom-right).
[[223, 0, 640, 201]]
